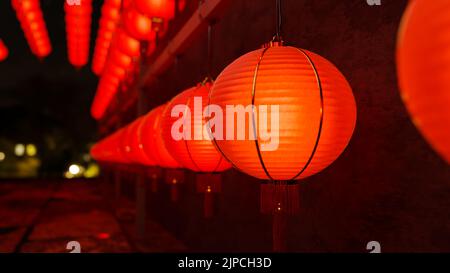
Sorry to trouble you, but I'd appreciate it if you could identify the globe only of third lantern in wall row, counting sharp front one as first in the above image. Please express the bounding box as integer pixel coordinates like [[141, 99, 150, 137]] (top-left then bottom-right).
[[141, 105, 180, 168]]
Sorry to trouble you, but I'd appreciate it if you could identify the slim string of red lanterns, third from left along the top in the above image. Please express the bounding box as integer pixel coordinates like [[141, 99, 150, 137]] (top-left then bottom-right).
[[92, 0, 122, 75]]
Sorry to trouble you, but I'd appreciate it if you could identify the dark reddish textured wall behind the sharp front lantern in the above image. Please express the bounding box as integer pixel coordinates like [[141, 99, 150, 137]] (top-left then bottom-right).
[[115, 0, 450, 252]]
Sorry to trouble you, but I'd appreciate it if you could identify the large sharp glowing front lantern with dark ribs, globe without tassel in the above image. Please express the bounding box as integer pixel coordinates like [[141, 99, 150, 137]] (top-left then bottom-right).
[[210, 43, 356, 180]]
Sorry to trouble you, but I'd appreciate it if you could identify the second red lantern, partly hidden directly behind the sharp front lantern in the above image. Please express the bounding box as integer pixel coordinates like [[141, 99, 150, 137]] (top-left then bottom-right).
[[162, 82, 231, 173]]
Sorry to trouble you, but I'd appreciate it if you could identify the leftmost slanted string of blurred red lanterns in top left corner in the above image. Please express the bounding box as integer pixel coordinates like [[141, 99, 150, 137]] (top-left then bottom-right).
[[11, 0, 52, 58]]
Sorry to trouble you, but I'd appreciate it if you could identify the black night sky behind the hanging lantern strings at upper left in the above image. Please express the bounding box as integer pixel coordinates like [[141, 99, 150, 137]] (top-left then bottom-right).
[[0, 0, 103, 173]]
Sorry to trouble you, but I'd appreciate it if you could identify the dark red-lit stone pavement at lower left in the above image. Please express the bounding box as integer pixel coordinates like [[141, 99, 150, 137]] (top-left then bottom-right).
[[0, 180, 186, 253]]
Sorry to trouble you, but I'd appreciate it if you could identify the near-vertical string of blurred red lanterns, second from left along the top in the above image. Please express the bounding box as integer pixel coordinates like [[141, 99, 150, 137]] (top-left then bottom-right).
[[64, 0, 92, 68]]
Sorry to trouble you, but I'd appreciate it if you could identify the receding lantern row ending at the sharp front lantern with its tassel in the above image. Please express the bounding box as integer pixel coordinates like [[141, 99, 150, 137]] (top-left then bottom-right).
[[92, 1, 356, 250]]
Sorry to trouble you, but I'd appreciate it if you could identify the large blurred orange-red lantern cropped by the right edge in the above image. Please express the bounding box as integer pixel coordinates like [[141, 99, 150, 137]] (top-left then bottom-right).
[[397, 0, 450, 164]]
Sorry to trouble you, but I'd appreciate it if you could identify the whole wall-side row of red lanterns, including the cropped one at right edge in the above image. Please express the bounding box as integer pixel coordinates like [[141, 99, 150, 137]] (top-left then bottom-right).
[[92, 0, 450, 250]]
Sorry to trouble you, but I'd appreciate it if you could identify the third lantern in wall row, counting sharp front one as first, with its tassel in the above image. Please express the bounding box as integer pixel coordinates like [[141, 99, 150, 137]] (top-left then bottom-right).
[[141, 105, 184, 201]]
